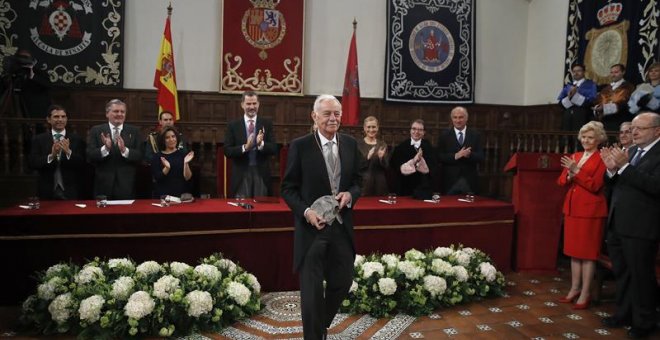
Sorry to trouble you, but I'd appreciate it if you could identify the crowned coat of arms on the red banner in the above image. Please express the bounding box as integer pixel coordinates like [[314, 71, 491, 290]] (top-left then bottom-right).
[[241, 0, 286, 60]]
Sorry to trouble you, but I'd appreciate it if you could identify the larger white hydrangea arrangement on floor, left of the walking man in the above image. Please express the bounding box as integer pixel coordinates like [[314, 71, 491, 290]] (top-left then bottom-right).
[[21, 253, 261, 339]]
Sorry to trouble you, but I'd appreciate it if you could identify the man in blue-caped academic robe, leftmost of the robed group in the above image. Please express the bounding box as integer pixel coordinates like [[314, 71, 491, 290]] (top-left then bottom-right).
[[557, 64, 596, 131]]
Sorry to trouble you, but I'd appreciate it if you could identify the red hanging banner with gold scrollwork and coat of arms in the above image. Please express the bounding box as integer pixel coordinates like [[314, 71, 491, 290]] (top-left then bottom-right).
[[220, 0, 305, 95]]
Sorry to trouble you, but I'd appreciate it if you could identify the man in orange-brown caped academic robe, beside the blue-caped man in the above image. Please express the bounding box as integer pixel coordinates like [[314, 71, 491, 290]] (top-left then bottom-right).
[[593, 64, 635, 131]]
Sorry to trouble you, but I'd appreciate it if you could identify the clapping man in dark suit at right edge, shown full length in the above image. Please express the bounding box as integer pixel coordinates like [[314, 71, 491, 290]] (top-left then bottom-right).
[[601, 112, 660, 338]]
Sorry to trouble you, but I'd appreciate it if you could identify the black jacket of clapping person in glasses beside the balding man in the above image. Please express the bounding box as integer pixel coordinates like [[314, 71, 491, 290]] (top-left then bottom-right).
[[390, 138, 438, 198]]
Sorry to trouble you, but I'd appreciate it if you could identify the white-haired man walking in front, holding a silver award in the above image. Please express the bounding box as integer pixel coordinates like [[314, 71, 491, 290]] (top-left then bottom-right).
[[281, 95, 361, 340]]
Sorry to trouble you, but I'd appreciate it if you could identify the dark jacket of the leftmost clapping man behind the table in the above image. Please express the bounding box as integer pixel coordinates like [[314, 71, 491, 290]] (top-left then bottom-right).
[[29, 129, 85, 200]]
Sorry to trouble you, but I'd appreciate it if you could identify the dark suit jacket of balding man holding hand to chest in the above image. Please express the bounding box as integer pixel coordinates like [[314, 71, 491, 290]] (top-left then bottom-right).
[[438, 127, 484, 194]]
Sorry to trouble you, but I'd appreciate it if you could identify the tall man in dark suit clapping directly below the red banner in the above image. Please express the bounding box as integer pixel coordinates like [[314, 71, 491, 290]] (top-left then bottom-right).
[[224, 91, 277, 197]]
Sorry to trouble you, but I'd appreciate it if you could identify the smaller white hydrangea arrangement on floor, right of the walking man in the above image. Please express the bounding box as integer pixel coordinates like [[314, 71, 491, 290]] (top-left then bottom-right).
[[341, 245, 505, 318]]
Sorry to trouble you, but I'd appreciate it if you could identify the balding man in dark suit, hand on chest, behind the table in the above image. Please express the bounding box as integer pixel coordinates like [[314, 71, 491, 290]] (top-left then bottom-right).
[[438, 106, 484, 195]]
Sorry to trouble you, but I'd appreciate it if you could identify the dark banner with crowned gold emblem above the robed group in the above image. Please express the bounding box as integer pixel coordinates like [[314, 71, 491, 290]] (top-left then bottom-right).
[[564, 0, 660, 85]]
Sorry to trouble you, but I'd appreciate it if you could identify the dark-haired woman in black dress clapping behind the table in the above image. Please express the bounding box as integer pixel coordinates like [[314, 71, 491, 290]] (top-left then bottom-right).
[[151, 126, 195, 198]]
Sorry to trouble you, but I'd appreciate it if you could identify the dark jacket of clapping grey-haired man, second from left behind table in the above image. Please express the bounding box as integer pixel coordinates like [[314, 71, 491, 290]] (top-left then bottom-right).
[[87, 123, 143, 199]]
